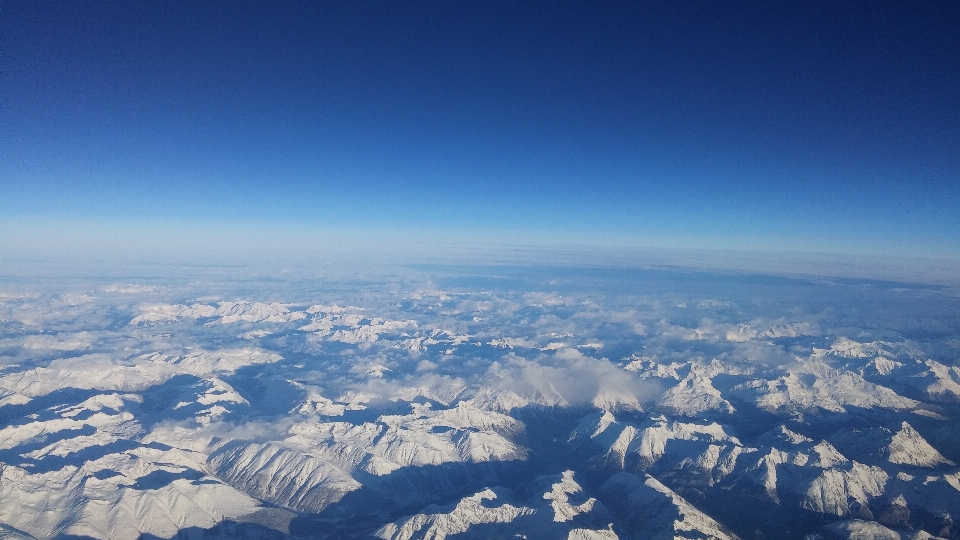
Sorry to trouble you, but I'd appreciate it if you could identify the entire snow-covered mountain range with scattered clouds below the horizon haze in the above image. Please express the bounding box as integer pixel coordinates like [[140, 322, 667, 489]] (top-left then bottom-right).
[[0, 268, 960, 540]]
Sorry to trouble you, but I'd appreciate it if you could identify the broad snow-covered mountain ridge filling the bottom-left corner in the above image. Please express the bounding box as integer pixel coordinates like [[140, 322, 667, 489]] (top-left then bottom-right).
[[0, 442, 259, 539]]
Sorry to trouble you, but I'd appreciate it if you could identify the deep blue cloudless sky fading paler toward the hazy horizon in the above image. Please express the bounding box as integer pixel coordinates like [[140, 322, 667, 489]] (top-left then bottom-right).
[[0, 0, 960, 257]]
